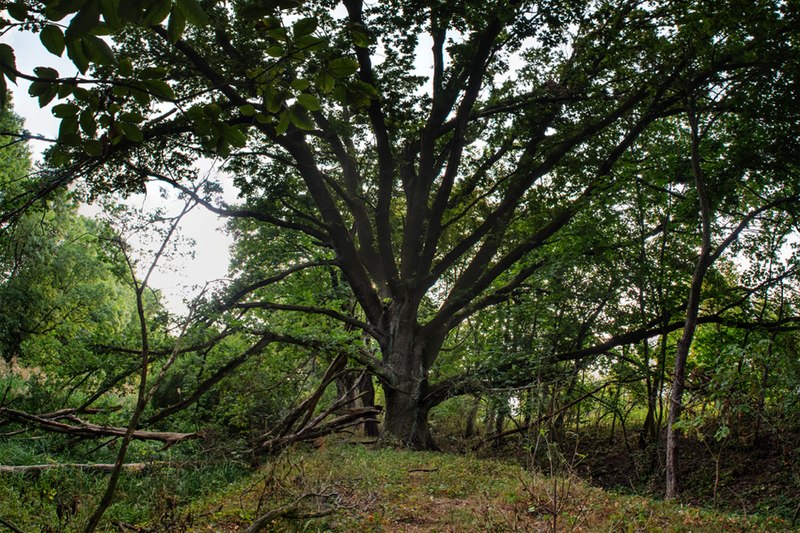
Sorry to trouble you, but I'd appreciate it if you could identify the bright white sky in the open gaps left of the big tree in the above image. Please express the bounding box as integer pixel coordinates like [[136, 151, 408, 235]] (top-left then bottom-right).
[[0, 30, 233, 313]]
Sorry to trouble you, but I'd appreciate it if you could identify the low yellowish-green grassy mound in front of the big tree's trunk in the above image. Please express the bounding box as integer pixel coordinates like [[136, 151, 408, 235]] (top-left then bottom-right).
[[162, 442, 791, 533]]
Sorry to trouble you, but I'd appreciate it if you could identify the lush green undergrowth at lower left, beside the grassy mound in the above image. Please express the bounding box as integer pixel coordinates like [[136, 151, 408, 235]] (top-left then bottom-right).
[[0, 436, 250, 533]]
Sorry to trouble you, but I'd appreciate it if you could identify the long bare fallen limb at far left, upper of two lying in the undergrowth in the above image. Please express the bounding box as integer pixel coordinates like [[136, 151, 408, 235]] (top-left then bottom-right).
[[0, 408, 200, 446]]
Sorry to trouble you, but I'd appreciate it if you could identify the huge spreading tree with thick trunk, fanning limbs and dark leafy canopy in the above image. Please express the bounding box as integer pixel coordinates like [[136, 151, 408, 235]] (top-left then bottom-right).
[[0, 0, 800, 456]]
